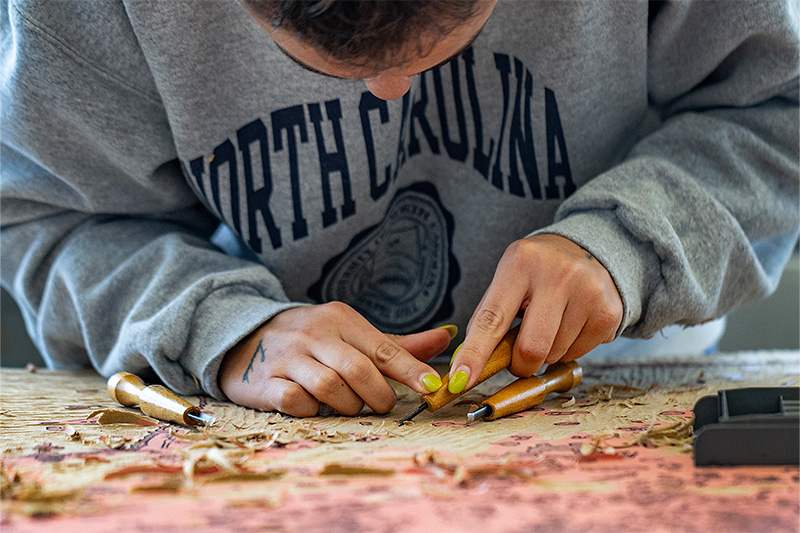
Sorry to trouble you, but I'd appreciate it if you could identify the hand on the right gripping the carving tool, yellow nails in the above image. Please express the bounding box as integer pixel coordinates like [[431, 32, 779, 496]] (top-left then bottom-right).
[[449, 234, 623, 392]]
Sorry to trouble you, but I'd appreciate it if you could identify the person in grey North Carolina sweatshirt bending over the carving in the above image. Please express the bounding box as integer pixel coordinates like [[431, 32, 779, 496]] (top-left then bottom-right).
[[0, 0, 800, 416]]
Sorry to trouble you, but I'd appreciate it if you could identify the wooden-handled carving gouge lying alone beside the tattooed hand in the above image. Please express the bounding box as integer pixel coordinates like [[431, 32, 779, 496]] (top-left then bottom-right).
[[106, 372, 215, 426]]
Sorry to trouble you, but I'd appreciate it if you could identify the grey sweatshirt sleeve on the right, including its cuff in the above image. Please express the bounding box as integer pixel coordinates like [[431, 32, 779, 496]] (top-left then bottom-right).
[[540, 0, 800, 337]]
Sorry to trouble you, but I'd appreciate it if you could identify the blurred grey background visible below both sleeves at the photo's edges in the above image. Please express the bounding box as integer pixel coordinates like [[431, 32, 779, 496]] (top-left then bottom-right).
[[0, 253, 800, 367]]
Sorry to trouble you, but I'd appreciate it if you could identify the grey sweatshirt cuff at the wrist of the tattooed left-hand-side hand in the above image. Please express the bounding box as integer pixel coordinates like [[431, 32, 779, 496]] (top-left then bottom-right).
[[181, 286, 308, 400]]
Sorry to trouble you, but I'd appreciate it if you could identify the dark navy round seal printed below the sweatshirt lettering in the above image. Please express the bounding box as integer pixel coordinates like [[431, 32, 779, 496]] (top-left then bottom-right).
[[308, 183, 459, 333]]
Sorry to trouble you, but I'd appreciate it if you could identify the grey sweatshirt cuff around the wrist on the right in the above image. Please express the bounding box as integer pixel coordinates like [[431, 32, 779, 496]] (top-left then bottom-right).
[[531, 210, 661, 337]]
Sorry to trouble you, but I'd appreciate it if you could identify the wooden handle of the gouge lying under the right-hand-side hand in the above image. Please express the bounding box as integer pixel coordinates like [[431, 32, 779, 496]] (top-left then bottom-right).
[[481, 361, 583, 420]]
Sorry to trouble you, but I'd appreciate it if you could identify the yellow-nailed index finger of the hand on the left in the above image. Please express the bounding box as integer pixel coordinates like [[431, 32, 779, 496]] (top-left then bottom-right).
[[342, 328, 442, 394]]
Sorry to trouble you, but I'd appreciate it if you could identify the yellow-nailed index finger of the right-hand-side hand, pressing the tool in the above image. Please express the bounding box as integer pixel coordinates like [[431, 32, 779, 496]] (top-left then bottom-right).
[[456, 270, 527, 393]]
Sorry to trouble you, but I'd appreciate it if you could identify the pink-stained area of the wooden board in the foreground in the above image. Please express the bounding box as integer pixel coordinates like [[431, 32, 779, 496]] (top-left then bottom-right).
[[3, 411, 800, 533]]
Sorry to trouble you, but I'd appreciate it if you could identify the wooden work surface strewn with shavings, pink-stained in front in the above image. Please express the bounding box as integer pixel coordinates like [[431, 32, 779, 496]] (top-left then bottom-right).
[[0, 351, 800, 533]]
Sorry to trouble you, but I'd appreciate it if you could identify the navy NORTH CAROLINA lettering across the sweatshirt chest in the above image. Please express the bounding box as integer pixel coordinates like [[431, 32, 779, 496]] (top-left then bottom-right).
[[181, 49, 576, 253]]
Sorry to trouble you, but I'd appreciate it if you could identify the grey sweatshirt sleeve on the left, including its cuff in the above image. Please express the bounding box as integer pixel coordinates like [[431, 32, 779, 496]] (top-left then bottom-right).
[[0, 2, 297, 398]]
